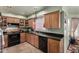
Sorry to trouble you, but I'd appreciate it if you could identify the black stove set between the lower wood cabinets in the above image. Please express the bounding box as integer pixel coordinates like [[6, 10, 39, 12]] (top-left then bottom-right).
[[8, 32, 20, 47]]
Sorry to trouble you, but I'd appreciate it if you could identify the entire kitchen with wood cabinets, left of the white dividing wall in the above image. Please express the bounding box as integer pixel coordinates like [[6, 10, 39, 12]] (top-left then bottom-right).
[[0, 6, 64, 53]]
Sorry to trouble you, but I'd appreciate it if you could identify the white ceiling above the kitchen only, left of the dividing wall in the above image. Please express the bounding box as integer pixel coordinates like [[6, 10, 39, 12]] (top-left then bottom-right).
[[0, 6, 46, 16]]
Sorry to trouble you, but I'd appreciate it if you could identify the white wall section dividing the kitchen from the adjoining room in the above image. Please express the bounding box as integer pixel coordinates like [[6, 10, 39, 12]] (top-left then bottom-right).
[[62, 7, 76, 52]]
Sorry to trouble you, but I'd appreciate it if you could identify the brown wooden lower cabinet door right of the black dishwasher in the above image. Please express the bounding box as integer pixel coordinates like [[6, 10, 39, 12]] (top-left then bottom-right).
[[48, 39, 60, 53]]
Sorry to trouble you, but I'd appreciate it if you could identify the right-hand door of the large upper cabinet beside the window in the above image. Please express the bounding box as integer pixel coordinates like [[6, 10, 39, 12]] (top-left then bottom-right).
[[50, 11, 60, 28]]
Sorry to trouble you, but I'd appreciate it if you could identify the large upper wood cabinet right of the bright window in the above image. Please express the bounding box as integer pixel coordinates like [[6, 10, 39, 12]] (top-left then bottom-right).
[[44, 11, 60, 29]]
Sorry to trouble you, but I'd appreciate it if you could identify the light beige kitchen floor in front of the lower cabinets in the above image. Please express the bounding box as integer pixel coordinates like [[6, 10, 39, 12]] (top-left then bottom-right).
[[3, 42, 43, 53]]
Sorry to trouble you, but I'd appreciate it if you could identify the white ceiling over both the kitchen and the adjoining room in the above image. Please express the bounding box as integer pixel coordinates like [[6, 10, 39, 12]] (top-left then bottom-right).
[[0, 6, 79, 16]]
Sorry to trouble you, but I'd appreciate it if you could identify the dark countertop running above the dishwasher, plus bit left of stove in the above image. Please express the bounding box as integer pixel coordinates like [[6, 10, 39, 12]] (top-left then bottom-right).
[[4, 31, 64, 41]]
